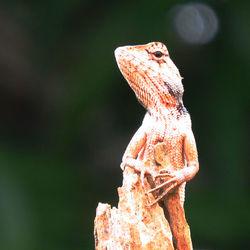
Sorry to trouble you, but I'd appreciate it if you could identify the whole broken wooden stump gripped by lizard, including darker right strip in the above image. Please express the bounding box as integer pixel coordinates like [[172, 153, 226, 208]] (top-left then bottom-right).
[[94, 143, 192, 250]]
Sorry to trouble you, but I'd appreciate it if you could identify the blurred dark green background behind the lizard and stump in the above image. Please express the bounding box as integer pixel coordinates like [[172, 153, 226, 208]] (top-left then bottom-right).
[[0, 0, 250, 250]]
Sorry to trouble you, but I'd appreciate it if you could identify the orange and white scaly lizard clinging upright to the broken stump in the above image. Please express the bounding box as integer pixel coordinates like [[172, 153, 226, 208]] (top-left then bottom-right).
[[115, 42, 199, 249]]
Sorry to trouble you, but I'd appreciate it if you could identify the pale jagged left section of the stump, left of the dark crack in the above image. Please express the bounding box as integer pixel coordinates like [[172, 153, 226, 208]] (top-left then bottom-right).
[[95, 168, 174, 250]]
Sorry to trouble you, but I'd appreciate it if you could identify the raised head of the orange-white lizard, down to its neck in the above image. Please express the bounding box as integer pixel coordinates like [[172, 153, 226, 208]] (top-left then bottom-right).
[[115, 42, 184, 111]]
